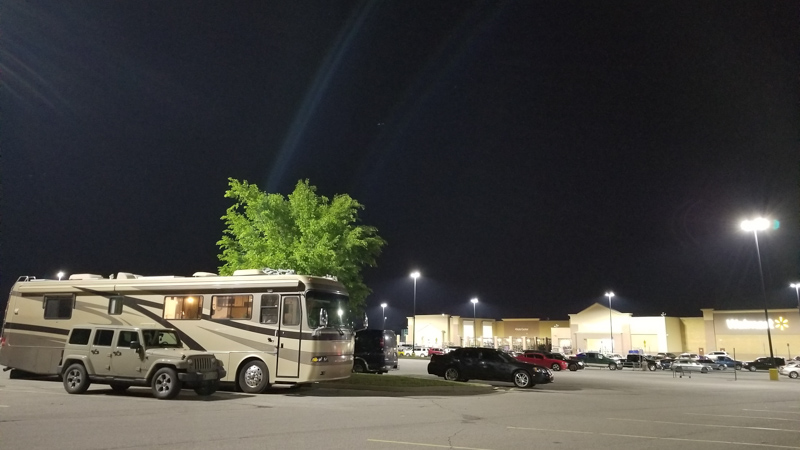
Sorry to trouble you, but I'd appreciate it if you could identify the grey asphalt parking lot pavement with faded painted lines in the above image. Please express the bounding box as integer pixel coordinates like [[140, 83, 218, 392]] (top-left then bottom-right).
[[0, 360, 800, 450]]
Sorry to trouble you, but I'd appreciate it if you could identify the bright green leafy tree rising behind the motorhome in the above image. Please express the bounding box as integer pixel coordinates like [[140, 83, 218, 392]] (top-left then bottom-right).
[[217, 178, 386, 311]]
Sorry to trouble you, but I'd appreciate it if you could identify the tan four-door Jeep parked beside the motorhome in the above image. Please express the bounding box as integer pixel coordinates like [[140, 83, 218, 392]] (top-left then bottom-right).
[[58, 325, 225, 399]]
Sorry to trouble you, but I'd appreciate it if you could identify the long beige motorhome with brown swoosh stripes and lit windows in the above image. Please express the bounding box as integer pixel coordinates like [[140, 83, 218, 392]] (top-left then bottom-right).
[[0, 269, 354, 393]]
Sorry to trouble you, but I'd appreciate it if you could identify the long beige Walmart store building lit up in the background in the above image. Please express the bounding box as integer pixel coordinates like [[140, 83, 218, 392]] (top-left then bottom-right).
[[401, 303, 800, 361]]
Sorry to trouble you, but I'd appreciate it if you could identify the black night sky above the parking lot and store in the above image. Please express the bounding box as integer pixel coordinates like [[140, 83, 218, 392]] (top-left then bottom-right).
[[0, 0, 800, 329]]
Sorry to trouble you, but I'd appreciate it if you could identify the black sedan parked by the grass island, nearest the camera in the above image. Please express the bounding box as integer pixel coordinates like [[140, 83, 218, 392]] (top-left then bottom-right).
[[428, 347, 553, 388]]
